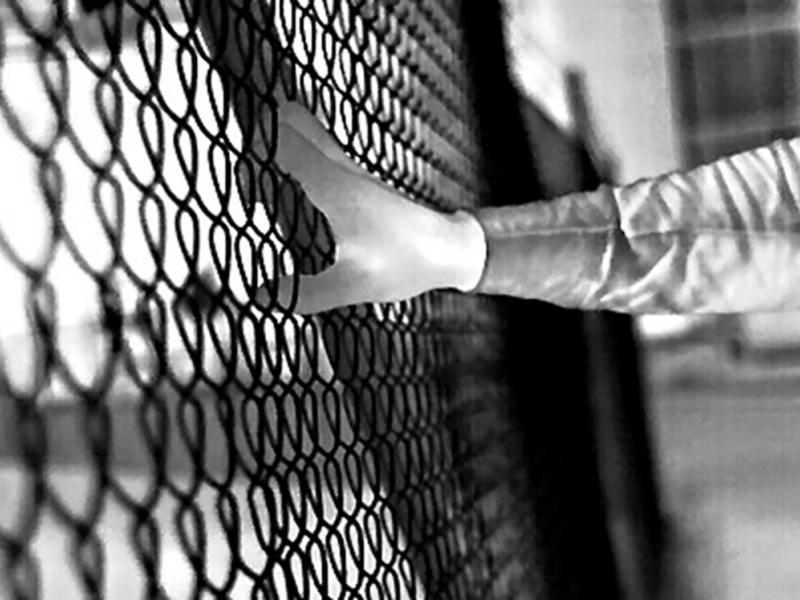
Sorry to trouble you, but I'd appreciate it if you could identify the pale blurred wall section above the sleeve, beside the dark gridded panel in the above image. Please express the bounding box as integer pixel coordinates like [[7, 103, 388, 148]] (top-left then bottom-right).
[[507, 0, 679, 181]]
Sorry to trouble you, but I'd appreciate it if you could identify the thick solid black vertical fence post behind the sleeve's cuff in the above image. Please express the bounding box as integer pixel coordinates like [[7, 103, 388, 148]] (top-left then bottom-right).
[[462, 0, 621, 599]]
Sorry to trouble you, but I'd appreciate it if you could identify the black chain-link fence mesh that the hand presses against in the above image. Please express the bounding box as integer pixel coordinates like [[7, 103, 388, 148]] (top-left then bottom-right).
[[0, 0, 620, 599]]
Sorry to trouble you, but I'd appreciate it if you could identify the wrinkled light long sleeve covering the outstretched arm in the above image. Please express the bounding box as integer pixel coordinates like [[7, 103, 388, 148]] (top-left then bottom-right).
[[475, 138, 800, 313]]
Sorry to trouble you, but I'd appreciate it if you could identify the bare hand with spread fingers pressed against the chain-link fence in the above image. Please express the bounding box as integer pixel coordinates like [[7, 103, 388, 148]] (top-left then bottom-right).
[[268, 103, 486, 314]]
